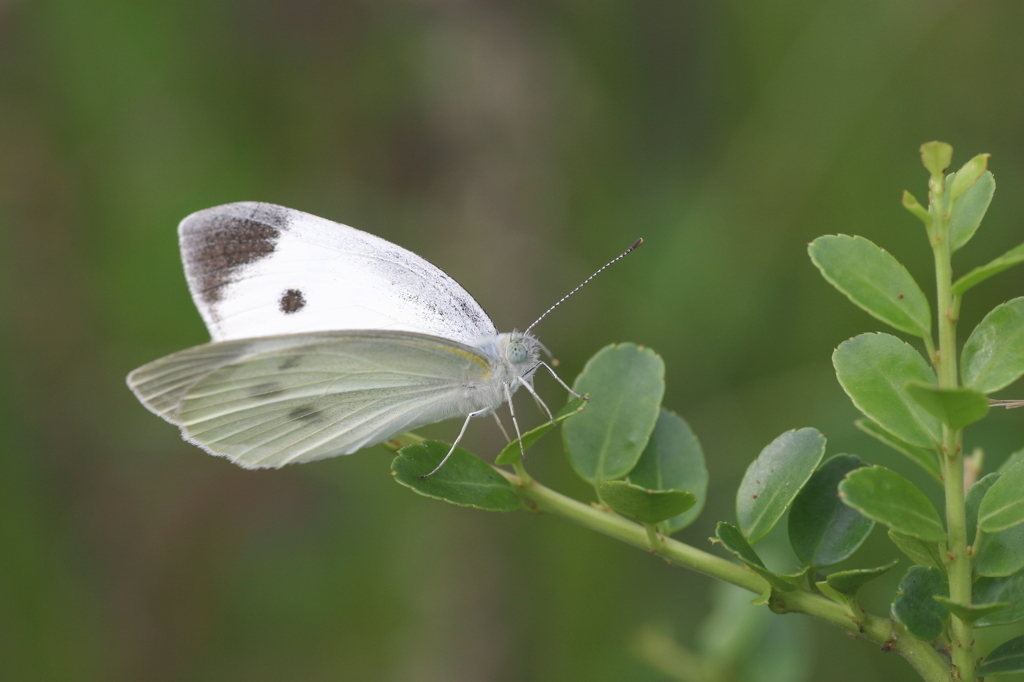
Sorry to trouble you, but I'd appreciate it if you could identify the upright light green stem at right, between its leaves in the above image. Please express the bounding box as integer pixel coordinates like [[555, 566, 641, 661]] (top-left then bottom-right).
[[929, 177, 975, 682]]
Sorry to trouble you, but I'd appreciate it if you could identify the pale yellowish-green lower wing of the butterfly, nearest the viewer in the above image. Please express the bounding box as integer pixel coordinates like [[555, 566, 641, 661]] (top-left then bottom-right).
[[128, 331, 502, 468]]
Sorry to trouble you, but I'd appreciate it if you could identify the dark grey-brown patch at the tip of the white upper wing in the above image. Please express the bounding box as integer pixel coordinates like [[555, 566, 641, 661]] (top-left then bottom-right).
[[180, 204, 289, 305]]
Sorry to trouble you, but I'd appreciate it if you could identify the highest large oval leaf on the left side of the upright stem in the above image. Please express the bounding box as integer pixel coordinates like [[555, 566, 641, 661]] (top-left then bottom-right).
[[807, 235, 932, 337]]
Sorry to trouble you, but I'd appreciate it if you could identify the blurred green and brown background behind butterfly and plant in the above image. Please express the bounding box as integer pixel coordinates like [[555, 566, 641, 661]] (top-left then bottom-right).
[[0, 0, 1024, 682]]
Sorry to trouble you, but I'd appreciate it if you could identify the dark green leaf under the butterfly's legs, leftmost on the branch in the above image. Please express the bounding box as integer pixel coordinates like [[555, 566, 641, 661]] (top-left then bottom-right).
[[391, 440, 521, 512]]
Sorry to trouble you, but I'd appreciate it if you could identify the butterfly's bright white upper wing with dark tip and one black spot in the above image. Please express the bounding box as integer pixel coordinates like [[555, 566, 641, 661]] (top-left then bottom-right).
[[178, 202, 497, 344]]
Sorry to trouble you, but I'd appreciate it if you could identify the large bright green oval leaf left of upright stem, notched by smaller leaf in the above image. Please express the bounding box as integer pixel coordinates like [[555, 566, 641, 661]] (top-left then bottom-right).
[[833, 334, 942, 447]]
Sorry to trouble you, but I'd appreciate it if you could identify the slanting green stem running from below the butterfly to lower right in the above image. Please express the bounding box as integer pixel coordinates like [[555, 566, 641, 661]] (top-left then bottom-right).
[[496, 467, 949, 682]]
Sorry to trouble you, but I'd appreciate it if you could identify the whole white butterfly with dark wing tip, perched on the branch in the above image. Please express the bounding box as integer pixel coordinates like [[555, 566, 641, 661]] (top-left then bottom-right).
[[128, 202, 641, 473]]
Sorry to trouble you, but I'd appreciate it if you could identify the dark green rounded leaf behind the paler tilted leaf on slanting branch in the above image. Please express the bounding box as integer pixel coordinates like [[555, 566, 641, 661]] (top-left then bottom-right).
[[790, 455, 874, 568]]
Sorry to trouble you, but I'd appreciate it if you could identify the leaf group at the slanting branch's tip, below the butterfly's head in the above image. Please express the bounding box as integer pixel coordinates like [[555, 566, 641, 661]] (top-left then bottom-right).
[[392, 343, 708, 535]]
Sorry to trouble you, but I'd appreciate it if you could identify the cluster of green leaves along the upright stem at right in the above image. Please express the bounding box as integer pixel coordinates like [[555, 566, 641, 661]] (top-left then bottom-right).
[[809, 142, 1024, 679]]
